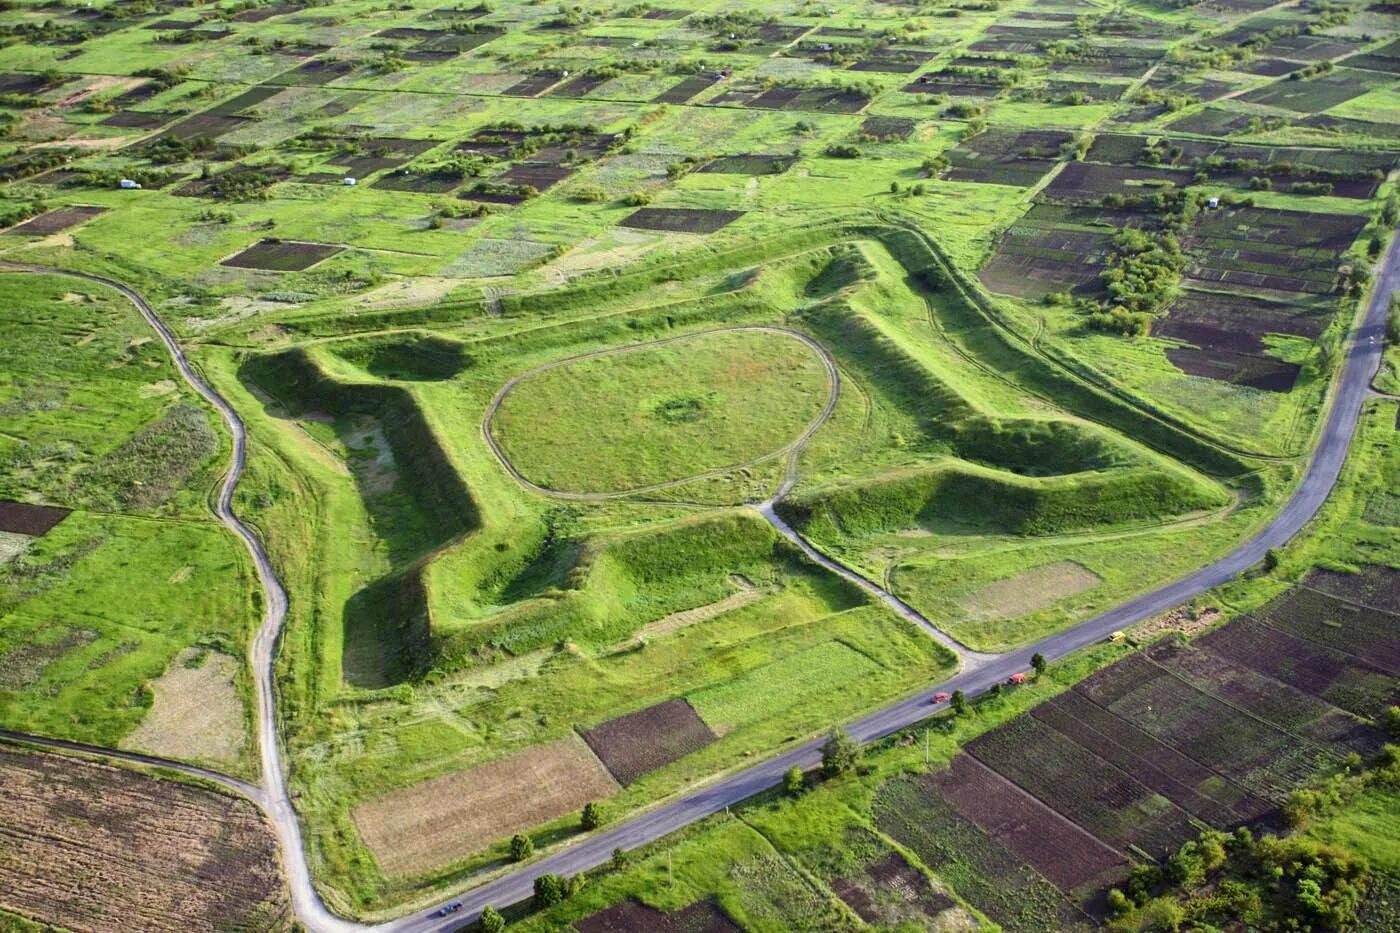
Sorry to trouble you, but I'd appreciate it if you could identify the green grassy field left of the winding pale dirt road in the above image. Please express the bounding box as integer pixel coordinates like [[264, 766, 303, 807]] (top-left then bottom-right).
[[0, 273, 255, 772]]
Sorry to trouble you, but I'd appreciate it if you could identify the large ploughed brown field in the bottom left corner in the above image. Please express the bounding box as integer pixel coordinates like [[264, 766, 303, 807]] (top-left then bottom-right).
[[0, 745, 293, 930]]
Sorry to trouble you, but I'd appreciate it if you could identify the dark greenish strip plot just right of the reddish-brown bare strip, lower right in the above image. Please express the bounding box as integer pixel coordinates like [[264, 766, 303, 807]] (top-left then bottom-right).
[[967, 716, 1196, 856]]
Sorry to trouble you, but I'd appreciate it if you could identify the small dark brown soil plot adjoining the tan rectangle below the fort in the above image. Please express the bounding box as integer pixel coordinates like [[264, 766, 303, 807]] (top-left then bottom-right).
[[582, 699, 715, 787]]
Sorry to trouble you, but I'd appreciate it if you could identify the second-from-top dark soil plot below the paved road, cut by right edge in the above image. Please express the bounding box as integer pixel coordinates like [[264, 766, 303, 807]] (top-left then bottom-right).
[[1254, 587, 1400, 677]]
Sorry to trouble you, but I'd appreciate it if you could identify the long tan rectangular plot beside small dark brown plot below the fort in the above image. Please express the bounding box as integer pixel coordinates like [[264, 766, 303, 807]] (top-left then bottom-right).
[[354, 735, 617, 876]]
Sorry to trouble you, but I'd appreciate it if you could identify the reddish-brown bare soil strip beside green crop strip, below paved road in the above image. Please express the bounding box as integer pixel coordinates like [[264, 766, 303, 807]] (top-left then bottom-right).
[[930, 749, 1127, 891]]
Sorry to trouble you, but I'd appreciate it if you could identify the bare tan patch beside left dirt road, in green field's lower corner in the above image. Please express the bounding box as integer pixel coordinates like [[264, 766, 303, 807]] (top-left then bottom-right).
[[122, 649, 248, 763]]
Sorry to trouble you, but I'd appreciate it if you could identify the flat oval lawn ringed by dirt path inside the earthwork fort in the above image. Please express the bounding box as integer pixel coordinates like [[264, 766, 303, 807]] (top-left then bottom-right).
[[487, 329, 832, 493]]
